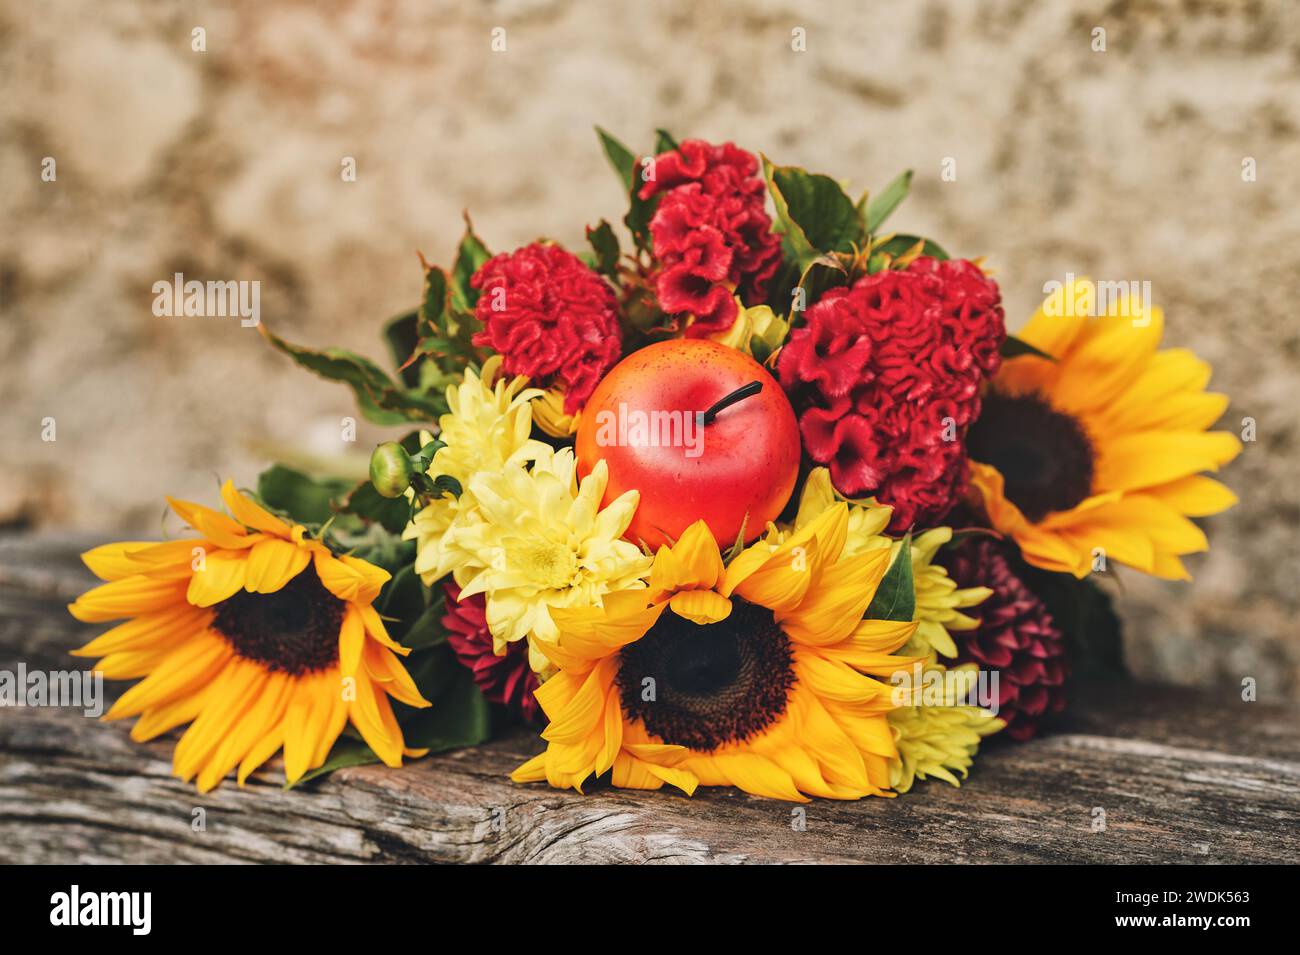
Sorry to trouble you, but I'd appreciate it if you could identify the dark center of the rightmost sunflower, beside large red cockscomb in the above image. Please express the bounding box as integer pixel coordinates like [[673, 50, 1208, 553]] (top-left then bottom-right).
[[966, 391, 1093, 522]]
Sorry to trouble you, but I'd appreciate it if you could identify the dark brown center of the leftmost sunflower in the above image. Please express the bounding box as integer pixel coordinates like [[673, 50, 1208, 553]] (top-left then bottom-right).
[[212, 567, 343, 677]]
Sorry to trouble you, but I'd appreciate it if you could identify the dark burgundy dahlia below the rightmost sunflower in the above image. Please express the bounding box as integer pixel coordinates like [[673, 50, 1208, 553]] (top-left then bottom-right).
[[940, 537, 1070, 739]]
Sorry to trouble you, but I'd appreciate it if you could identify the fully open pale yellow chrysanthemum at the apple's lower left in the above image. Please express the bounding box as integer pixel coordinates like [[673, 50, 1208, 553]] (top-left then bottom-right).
[[443, 446, 650, 672]]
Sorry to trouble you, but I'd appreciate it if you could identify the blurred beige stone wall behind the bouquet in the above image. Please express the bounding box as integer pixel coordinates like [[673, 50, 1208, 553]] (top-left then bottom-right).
[[0, 0, 1300, 706]]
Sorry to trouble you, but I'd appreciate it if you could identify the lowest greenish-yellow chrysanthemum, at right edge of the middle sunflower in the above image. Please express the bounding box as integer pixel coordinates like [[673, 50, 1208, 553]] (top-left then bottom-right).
[[888, 664, 1006, 793]]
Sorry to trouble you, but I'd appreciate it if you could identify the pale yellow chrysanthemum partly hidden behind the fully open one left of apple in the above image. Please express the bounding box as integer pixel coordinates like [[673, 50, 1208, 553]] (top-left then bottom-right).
[[402, 355, 550, 585]]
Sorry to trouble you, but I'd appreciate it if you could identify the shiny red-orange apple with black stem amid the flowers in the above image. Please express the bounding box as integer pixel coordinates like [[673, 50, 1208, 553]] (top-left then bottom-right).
[[575, 338, 800, 548]]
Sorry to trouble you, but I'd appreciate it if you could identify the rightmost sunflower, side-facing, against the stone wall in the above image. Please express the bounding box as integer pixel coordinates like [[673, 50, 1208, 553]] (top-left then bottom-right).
[[967, 281, 1242, 579]]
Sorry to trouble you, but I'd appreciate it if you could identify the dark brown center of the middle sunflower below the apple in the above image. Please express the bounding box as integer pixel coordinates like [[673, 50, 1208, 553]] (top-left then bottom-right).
[[618, 598, 794, 752]]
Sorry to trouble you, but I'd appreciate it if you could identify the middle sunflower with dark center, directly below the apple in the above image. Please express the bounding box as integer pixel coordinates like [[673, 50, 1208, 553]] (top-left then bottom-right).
[[512, 503, 917, 802]]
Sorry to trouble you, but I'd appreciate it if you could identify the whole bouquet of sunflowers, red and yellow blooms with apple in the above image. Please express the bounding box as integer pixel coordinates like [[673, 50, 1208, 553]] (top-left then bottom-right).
[[70, 131, 1240, 800]]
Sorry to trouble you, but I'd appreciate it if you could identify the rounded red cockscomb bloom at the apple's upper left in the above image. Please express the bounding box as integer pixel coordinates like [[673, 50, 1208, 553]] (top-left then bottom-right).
[[469, 243, 623, 414]]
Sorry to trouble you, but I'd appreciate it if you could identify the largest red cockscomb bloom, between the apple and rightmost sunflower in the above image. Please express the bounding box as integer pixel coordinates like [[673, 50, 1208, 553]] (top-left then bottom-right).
[[777, 257, 1006, 531]]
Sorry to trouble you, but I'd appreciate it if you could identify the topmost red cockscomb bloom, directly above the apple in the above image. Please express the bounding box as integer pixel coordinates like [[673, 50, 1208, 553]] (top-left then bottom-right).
[[640, 139, 781, 338]]
